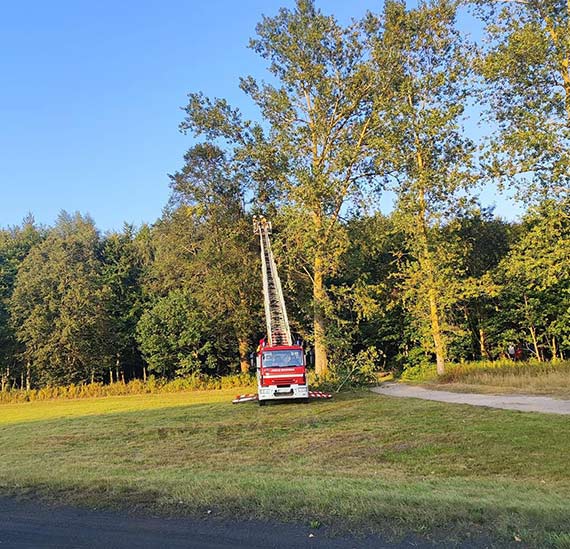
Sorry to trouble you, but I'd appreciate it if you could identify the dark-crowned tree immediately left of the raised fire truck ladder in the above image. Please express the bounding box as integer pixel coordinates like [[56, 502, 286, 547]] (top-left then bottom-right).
[[150, 144, 261, 372]]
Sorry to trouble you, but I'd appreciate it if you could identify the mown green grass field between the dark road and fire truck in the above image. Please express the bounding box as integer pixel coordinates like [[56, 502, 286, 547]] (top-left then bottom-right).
[[0, 391, 570, 547]]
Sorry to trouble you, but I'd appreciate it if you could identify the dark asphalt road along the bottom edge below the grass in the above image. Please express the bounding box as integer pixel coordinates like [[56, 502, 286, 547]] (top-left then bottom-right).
[[0, 498, 424, 549]]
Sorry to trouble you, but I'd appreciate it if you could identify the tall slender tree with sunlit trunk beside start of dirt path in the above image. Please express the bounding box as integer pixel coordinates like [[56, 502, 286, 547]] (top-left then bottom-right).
[[367, 0, 473, 374]]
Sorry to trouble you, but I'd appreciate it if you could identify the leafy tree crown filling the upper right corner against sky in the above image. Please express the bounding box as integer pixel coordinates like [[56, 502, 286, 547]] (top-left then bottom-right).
[[474, 0, 570, 201]]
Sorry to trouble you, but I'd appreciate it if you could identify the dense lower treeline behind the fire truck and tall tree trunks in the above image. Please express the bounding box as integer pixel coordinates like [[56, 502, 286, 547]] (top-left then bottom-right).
[[0, 200, 570, 389]]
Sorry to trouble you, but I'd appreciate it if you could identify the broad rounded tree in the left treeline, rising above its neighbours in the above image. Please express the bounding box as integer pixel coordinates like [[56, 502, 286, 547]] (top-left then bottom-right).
[[10, 213, 112, 384]]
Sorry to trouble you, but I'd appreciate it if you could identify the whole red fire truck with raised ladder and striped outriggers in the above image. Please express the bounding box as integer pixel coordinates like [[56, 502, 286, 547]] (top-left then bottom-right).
[[234, 217, 331, 406]]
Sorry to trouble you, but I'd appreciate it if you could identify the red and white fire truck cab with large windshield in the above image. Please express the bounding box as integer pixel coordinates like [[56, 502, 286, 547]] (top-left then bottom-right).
[[256, 345, 309, 406]]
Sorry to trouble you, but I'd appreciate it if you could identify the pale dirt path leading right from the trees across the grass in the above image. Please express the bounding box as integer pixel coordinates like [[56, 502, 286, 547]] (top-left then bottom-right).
[[372, 383, 570, 415]]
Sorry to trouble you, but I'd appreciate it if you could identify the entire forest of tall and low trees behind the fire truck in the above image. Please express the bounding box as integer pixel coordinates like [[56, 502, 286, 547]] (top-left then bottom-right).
[[0, 0, 570, 391]]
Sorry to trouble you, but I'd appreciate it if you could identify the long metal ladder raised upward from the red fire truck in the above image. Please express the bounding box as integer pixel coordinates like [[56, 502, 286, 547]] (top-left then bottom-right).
[[253, 217, 293, 346]]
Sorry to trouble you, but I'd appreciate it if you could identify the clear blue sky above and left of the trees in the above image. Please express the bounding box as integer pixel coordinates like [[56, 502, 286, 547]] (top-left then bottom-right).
[[0, 0, 514, 230]]
